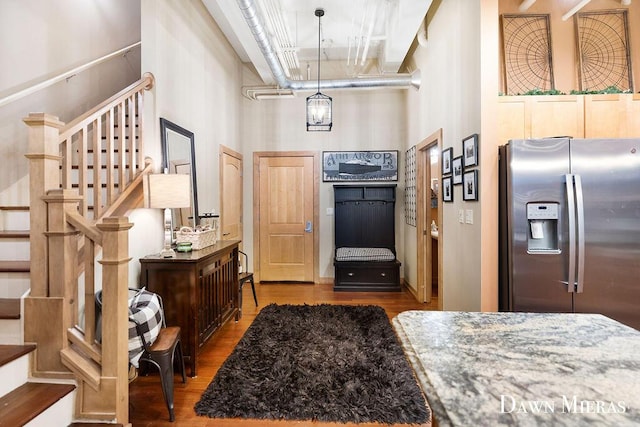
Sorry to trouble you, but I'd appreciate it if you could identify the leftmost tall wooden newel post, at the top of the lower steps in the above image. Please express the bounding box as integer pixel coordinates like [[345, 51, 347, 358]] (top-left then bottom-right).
[[22, 113, 64, 297]]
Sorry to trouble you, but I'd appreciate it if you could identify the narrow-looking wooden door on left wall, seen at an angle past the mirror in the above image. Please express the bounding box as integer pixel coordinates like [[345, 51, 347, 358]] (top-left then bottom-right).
[[220, 145, 242, 240]]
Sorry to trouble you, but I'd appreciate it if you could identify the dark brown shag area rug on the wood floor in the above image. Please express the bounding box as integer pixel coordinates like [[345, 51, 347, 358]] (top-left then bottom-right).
[[195, 304, 430, 424]]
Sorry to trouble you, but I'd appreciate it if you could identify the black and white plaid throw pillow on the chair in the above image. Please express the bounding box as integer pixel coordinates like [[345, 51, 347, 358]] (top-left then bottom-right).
[[129, 288, 162, 368]]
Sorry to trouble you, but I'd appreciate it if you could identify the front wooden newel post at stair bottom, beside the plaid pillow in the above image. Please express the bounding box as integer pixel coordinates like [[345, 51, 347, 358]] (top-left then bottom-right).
[[96, 217, 133, 424]]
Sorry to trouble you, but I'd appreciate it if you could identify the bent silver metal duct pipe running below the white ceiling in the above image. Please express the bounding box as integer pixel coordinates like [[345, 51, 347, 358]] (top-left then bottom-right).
[[237, 0, 421, 91]]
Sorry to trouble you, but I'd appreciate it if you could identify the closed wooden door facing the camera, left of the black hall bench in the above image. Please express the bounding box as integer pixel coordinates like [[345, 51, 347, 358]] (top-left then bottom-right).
[[254, 155, 317, 282]]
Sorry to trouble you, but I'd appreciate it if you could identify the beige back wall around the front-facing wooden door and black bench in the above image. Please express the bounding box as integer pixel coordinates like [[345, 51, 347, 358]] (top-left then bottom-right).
[[241, 65, 413, 278]]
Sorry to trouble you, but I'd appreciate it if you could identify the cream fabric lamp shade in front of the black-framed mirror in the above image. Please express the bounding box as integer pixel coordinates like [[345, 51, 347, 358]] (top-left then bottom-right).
[[142, 173, 191, 209]]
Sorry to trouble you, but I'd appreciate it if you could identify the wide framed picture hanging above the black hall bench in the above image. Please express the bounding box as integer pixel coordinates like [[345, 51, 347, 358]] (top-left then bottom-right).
[[322, 150, 398, 182]]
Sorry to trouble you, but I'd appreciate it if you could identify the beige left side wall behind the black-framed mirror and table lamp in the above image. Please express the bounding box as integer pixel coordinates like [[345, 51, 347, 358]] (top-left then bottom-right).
[[137, 0, 243, 280]]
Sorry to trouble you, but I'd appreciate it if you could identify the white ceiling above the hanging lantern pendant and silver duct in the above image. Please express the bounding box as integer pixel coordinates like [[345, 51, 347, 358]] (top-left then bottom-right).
[[203, 0, 432, 84]]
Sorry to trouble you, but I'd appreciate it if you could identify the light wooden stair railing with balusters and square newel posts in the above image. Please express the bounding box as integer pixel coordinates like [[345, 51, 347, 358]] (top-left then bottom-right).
[[24, 74, 153, 424]]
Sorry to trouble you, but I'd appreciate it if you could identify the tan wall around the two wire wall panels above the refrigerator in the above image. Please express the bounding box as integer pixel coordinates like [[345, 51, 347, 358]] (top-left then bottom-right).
[[499, 0, 640, 93]]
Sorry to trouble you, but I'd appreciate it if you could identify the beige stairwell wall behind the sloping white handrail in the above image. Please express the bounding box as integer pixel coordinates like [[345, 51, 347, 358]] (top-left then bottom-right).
[[0, 0, 140, 205]]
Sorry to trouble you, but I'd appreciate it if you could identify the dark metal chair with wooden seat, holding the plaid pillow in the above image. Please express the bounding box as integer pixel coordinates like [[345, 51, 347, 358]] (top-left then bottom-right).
[[129, 294, 187, 422]]
